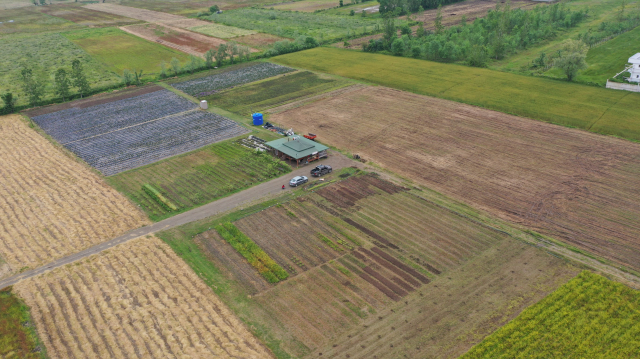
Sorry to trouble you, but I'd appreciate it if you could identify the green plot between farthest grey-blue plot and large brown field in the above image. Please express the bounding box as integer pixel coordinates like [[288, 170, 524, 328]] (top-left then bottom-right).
[[204, 71, 350, 115]]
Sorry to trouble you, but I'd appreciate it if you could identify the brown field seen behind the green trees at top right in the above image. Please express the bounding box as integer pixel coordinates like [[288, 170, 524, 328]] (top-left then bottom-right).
[[333, 0, 544, 49]]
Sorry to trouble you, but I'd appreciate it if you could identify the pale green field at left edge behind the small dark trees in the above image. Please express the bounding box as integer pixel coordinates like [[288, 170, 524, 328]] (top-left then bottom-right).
[[0, 33, 120, 105]]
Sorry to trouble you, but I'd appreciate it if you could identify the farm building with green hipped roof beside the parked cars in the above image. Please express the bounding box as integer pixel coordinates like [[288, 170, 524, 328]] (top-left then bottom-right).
[[265, 136, 329, 165]]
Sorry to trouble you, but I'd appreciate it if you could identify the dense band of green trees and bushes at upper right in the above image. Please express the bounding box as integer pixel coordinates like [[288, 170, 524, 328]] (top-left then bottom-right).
[[363, 3, 588, 67]]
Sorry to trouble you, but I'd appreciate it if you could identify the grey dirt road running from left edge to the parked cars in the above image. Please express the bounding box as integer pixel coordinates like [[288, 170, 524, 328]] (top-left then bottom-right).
[[0, 151, 362, 289]]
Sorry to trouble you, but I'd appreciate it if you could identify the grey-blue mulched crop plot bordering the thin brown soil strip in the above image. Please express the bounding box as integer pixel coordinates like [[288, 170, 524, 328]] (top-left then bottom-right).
[[33, 90, 196, 144]]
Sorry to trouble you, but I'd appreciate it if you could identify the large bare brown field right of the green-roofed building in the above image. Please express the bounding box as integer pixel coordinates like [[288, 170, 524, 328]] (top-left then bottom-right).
[[270, 87, 640, 270]]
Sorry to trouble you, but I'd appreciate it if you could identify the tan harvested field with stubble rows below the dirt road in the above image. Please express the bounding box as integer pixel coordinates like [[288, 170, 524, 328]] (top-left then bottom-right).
[[14, 236, 272, 359]]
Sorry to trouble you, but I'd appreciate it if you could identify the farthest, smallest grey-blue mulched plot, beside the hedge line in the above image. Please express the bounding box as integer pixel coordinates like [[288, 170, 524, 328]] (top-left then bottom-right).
[[171, 62, 294, 98]]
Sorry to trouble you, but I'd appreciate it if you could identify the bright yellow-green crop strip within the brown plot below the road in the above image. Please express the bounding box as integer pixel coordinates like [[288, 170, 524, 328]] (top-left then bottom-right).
[[216, 222, 289, 283]]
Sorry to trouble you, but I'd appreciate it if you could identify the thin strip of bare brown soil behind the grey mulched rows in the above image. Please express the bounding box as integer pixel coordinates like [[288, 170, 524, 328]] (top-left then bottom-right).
[[24, 85, 164, 117]]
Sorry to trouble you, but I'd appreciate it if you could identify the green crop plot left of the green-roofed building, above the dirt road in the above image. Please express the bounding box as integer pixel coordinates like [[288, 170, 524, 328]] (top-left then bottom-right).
[[106, 141, 291, 221]]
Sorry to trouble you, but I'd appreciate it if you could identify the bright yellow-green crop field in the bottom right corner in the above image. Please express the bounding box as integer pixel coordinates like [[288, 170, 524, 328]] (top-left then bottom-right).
[[461, 271, 640, 359]]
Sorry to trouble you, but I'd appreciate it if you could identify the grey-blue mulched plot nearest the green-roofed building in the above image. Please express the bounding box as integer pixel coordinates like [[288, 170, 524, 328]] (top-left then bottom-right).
[[67, 110, 247, 176]]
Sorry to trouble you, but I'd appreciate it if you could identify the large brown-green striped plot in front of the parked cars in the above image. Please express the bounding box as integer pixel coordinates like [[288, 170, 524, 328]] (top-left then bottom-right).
[[166, 175, 577, 358]]
